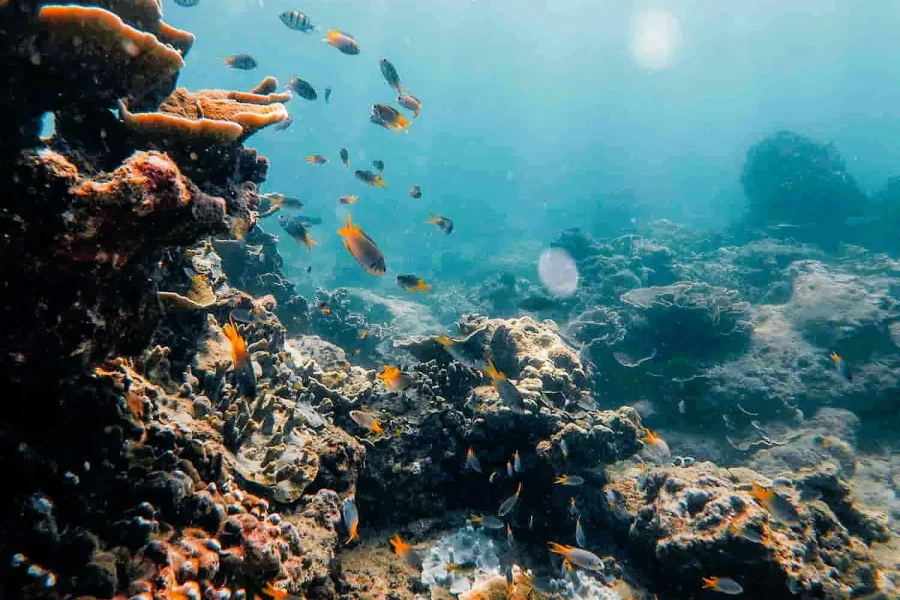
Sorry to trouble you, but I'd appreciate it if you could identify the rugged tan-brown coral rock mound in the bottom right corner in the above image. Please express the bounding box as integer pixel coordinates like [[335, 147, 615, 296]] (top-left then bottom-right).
[[607, 463, 888, 598]]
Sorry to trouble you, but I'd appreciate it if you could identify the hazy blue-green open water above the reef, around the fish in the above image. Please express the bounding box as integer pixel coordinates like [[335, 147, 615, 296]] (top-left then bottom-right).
[[164, 0, 900, 292]]
